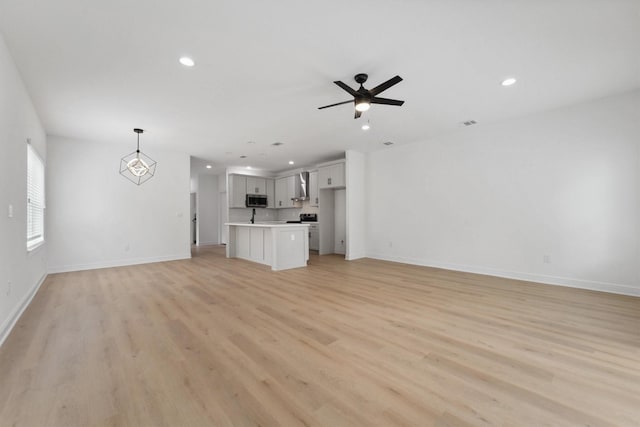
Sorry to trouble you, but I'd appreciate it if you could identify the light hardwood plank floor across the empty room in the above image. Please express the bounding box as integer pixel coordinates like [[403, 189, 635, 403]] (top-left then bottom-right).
[[0, 247, 640, 427]]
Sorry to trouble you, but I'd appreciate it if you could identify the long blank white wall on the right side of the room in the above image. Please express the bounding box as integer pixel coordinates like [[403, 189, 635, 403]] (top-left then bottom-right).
[[366, 91, 640, 295]]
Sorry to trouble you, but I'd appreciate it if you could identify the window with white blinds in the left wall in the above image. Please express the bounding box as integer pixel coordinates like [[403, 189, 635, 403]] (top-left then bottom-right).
[[27, 144, 44, 250]]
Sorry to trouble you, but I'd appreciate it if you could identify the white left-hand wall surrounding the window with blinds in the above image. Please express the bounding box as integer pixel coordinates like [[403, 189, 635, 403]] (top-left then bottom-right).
[[0, 36, 49, 344]]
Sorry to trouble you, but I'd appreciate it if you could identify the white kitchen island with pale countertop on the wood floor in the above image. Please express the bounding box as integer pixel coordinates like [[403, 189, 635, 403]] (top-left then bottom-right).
[[225, 222, 309, 271]]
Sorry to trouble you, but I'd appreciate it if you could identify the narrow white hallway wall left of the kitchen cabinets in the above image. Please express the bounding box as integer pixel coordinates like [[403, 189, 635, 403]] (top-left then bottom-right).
[[196, 174, 220, 245]]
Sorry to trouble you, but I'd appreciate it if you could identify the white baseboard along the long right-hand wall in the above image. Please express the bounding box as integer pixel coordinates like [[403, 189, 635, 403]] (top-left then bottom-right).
[[367, 254, 640, 297]]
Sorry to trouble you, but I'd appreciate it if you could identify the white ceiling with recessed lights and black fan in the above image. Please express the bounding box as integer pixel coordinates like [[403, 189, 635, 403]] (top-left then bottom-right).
[[0, 0, 640, 171]]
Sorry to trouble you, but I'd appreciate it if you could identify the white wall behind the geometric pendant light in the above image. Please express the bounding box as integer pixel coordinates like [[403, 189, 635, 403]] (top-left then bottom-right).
[[47, 133, 191, 272]]
